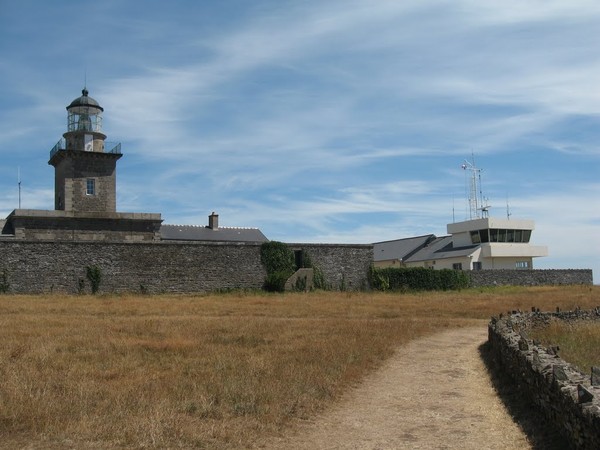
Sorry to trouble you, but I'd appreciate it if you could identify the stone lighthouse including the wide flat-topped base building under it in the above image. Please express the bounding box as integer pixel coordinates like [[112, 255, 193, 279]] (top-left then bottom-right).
[[0, 88, 162, 242]]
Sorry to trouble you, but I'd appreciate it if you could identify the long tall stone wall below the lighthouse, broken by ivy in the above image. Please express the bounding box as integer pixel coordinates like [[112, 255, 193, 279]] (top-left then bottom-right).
[[0, 238, 373, 294]]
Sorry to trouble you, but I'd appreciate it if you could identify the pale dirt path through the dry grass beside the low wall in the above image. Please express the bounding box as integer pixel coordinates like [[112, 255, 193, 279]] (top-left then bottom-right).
[[260, 325, 532, 450]]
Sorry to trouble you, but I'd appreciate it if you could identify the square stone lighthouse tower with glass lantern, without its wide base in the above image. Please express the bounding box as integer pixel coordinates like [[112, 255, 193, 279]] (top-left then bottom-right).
[[48, 88, 122, 212]]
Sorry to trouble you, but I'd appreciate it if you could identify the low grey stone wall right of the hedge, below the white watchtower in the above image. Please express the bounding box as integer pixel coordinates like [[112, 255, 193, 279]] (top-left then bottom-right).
[[470, 269, 593, 287]]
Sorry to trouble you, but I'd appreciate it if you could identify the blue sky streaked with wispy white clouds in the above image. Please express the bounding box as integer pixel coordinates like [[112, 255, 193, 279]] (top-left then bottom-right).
[[0, 0, 600, 282]]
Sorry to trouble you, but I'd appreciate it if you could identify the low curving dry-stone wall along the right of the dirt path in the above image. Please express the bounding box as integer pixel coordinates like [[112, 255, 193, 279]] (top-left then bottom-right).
[[489, 308, 600, 449]]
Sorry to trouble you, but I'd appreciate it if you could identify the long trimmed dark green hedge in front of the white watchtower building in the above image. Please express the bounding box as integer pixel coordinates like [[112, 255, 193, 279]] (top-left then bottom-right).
[[369, 267, 471, 291]]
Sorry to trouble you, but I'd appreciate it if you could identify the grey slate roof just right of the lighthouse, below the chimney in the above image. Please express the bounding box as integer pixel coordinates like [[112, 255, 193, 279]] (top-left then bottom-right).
[[160, 225, 268, 242]]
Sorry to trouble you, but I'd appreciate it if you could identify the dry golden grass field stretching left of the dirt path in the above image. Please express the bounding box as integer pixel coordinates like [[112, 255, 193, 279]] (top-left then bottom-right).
[[0, 286, 600, 448]]
